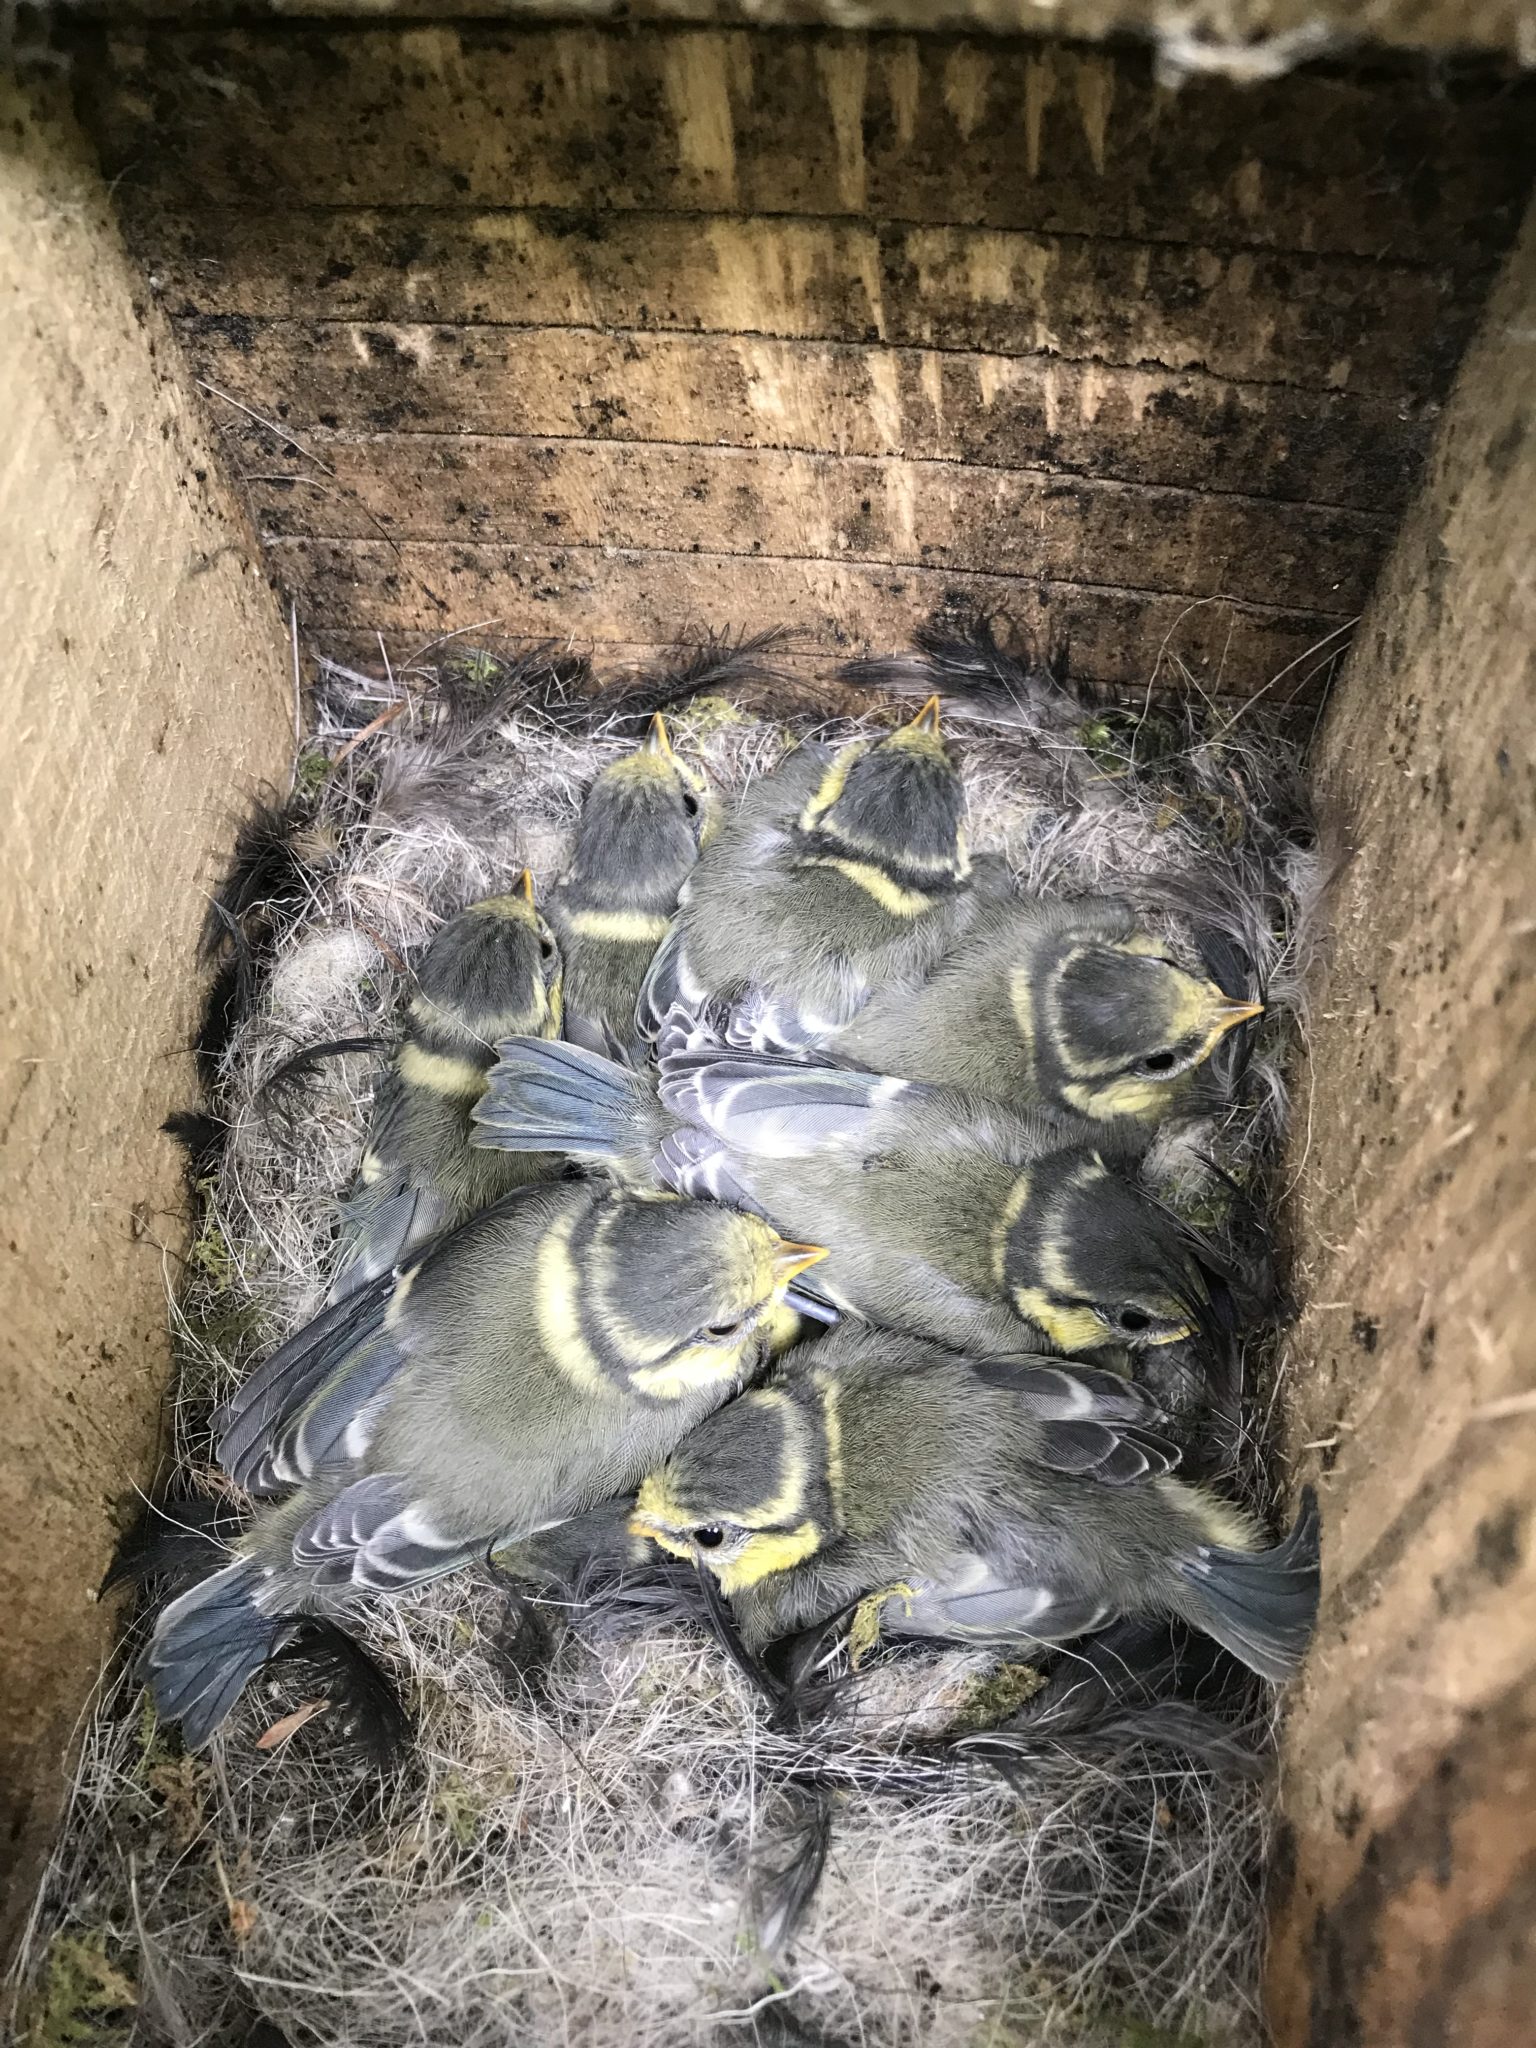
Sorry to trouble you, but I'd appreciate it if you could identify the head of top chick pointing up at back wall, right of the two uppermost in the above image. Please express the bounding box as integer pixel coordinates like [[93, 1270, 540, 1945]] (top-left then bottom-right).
[[799, 696, 971, 907]]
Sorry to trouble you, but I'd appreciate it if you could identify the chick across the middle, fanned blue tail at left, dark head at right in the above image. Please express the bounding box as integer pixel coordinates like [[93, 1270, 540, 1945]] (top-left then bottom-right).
[[475, 1040, 1225, 1358]]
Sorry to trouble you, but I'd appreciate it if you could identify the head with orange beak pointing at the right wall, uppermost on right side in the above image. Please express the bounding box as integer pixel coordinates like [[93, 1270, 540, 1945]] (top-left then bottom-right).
[[1036, 934, 1264, 1120]]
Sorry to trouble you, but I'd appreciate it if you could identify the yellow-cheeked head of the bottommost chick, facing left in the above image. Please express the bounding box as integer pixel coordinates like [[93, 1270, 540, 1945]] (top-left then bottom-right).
[[629, 1386, 838, 1595]]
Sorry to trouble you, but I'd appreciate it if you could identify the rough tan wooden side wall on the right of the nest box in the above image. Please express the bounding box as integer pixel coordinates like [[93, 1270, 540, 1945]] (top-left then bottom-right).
[[1270, 195, 1536, 2048]]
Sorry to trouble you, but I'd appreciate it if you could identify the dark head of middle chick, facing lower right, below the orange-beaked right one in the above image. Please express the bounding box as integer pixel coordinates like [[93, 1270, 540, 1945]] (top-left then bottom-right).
[[993, 1147, 1210, 1356]]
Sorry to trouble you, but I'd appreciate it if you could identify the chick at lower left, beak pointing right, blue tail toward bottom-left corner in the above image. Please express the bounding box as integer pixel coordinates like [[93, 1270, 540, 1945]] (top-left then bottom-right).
[[145, 1182, 821, 1747]]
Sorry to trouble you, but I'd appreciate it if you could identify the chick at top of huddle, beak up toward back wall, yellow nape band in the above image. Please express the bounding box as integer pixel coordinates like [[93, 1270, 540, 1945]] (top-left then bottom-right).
[[639, 698, 987, 1047]]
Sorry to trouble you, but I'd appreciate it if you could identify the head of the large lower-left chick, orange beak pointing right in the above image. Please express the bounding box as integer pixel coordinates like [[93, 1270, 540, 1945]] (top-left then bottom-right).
[[535, 1194, 825, 1401]]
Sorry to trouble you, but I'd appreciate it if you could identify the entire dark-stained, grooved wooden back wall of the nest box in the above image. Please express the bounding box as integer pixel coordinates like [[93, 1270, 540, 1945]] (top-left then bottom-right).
[[80, 23, 1536, 696]]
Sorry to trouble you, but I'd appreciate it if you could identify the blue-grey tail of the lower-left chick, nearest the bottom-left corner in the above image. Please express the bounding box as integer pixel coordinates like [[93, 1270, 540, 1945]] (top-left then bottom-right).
[[143, 1559, 295, 1749]]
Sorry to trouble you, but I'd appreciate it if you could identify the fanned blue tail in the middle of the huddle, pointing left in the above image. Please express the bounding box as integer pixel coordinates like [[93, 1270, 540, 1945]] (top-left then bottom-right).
[[473, 1038, 664, 1180]]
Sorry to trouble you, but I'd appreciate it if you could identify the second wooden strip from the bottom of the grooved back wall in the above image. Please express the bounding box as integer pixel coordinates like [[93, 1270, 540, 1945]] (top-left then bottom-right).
[[242, 428, 1389, 614]]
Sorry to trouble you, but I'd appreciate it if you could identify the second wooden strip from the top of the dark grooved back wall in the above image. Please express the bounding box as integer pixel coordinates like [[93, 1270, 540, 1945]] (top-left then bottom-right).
[[123, 188, 1477, 399]]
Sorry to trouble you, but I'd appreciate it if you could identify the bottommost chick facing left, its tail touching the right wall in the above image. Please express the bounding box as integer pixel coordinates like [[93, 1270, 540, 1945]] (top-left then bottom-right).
[[631, 1325, 1319, 1681]]
